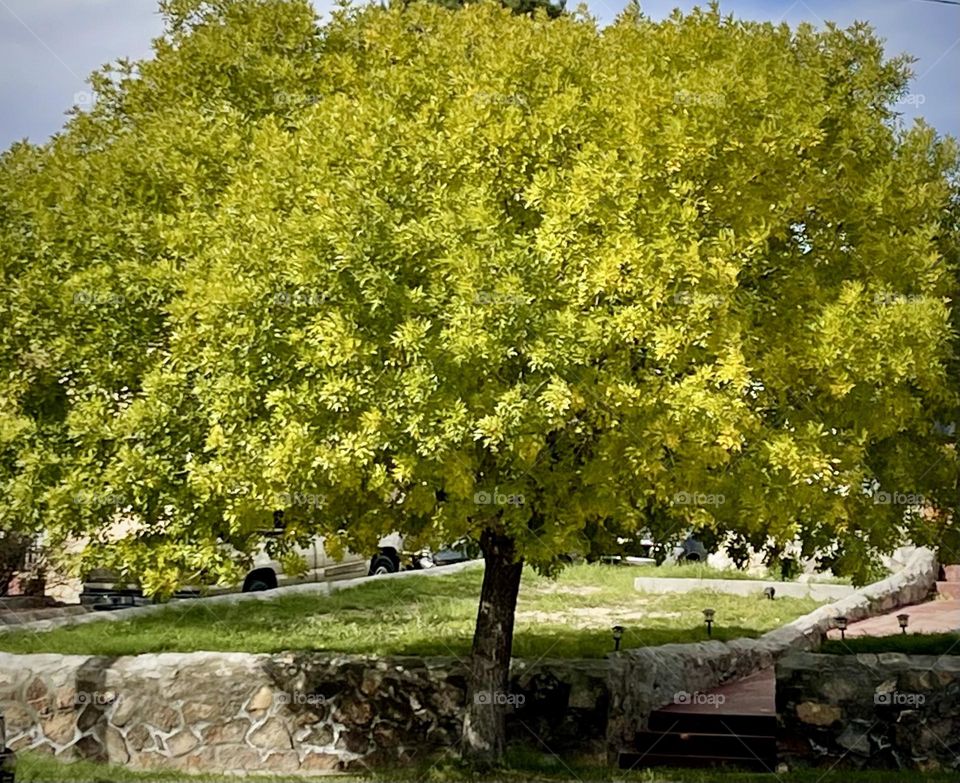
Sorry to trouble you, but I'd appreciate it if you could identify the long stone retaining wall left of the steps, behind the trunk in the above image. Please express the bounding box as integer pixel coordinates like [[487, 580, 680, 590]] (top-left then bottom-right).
[[0, 653, 609, 773]]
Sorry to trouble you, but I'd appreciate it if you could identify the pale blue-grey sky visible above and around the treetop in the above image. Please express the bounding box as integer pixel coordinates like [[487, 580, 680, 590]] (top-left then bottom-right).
[[0, 0, 960, 149]]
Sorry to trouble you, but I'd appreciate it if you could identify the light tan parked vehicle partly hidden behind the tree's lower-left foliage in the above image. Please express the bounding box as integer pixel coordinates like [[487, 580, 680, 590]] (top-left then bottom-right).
[[80, 533, 403, 610]]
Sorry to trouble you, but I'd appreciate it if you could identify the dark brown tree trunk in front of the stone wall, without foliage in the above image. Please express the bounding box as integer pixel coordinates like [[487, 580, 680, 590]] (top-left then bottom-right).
[[463, 530, 523, 766]]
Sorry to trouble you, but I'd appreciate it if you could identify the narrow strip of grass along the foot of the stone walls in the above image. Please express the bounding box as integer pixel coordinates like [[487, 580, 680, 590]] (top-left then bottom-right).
[[17, 751, 956, 783]]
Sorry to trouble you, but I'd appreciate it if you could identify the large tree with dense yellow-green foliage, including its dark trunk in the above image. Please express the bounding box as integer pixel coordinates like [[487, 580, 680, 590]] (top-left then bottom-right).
[[0, 0, 957, 761]]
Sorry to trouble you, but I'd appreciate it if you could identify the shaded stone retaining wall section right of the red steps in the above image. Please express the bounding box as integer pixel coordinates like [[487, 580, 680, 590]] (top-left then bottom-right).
[[777, 653, 960, 770]]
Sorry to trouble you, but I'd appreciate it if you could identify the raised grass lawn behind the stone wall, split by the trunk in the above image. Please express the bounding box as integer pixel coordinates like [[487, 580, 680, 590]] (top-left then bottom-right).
[[0, 564, 819, 658]]
